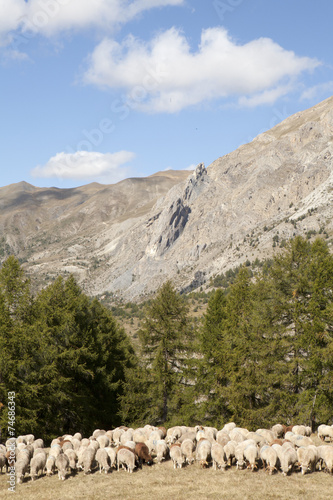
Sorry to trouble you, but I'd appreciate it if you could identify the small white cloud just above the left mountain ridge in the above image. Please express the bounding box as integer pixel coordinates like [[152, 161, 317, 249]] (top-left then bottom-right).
[[30, 151, 135, 182]]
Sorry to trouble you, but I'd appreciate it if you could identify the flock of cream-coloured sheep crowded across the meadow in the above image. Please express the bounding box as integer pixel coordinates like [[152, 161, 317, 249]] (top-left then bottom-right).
[[0, 422, 333, 483]]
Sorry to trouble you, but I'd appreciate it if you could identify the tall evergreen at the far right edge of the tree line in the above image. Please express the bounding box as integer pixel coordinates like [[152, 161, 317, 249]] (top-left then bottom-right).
[[270, 237, 333, 423]]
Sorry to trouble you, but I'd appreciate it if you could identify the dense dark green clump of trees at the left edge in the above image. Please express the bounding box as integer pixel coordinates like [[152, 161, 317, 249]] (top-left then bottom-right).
[[0, 258, 134, 438]]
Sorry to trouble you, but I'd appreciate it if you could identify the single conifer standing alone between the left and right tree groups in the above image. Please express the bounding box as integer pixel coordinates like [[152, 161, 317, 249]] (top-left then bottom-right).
[[126, 282, 193, 424]]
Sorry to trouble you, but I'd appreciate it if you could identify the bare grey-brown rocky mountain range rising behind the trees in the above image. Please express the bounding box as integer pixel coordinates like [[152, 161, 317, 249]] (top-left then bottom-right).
[[0, 97, 333, 300]]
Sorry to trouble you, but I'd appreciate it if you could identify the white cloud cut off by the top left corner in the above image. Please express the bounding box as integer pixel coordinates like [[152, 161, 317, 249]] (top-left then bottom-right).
[[0, 0, 184, 39]]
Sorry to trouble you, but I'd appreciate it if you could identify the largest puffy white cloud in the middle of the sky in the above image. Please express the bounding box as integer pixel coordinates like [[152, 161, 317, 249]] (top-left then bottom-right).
[[83, 27, 320, 113]]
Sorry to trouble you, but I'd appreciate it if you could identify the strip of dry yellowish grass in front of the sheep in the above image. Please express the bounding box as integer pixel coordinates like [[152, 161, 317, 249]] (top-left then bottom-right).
[[0, 461, 333, 500]]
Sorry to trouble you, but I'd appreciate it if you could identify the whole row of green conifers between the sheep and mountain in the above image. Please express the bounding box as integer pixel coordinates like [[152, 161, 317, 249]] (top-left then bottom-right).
[[0, 237, 333, 437]]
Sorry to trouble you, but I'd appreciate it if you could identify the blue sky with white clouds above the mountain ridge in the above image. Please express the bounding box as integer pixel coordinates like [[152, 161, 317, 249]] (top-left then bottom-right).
[[0, 0, 333, 188]]
